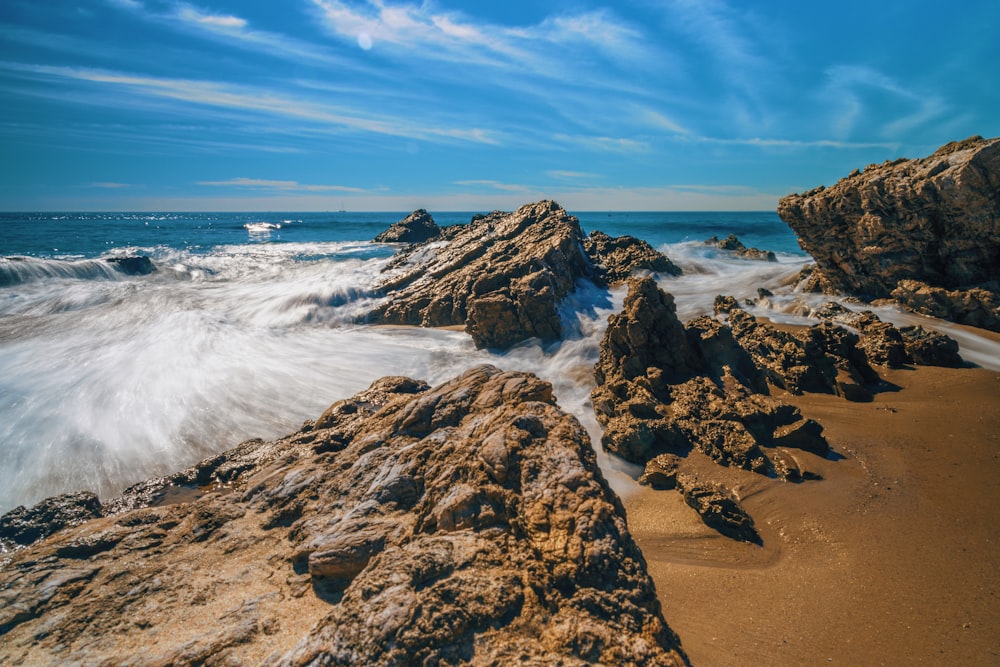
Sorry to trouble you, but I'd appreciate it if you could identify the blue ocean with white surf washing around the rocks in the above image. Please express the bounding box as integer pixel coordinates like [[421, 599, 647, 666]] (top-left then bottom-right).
[[0, 211, 1000, 513]]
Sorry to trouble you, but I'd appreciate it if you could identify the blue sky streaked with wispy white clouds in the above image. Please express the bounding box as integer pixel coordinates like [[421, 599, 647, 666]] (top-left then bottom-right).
[[0, 0, 1000, 211]]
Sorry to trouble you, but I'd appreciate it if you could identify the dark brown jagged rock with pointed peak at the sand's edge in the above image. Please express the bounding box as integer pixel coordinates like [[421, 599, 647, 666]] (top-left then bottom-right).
[[591, 278, 821, 474]]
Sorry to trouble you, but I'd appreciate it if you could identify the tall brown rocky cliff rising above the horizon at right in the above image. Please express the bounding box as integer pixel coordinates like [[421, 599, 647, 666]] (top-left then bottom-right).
[[778, 137, 1000, 331]]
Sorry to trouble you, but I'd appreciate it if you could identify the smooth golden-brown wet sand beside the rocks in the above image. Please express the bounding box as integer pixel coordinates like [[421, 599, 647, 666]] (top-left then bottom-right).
[[624, 367, 1000, 667]]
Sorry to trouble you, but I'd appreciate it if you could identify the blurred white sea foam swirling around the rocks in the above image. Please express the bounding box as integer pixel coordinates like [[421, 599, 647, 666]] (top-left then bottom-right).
[[0, 243, 1000, 512]]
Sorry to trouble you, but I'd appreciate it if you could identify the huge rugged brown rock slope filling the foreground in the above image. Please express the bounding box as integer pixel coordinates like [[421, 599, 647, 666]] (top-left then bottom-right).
[[0, 367, 686, 665]]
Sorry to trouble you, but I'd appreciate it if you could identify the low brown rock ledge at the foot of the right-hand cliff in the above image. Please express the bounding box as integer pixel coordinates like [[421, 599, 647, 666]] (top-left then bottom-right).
[[892, 280, 1000, 331]]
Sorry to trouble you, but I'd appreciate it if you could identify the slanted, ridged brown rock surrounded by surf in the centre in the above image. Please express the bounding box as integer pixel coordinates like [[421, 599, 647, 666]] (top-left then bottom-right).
[[368, 201, 600, 349]]
